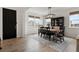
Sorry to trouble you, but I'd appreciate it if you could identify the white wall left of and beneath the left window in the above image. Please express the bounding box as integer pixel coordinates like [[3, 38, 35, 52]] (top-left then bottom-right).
[[24, 11, 38, 35]]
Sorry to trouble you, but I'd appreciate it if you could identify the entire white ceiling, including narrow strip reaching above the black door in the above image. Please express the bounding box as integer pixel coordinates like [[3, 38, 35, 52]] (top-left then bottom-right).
[[5, 7, 79, 16]]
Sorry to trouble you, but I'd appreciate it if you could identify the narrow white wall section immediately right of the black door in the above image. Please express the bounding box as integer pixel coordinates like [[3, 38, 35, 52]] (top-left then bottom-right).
[[17, 10, 24, 37]]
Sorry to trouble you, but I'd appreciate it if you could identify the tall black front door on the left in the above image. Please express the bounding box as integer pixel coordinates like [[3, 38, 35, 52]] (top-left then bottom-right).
[[3, 8, 16, 39]]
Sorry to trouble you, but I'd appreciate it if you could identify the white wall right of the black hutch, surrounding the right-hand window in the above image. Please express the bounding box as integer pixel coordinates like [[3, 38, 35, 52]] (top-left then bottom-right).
[[65, 8, 79, 38]]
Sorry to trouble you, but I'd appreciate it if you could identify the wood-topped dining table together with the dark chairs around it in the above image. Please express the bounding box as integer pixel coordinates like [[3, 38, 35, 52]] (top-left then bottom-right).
[[38, 26, 64, 43]]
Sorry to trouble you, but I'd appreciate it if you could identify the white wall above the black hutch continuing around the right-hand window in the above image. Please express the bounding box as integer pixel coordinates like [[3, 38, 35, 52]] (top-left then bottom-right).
[[55, 8, 79, 38]]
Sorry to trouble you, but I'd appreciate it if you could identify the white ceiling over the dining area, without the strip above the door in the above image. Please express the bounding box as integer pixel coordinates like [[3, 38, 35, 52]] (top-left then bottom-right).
[[26, 7, 79, 16]]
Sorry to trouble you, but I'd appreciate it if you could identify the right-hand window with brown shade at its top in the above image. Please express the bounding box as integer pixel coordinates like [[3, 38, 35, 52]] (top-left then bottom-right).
[[69, 11, 79, 28]]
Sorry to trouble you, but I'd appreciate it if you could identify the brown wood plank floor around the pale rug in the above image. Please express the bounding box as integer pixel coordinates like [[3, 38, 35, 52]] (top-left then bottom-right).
[[0, 35, 75, 52]]
